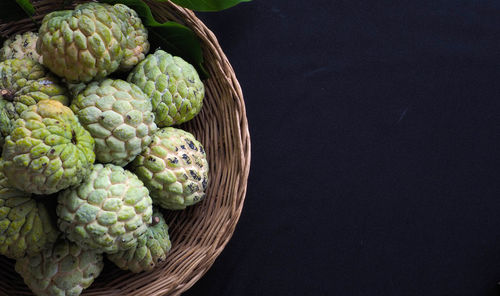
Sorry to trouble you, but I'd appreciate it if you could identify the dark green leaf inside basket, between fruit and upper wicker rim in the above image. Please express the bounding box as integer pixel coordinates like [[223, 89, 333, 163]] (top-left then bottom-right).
[[100, 0, 209, 79]]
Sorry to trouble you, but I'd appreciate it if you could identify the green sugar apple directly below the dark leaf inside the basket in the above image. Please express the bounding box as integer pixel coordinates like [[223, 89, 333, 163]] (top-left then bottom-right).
[[127, 50, 205, 127]]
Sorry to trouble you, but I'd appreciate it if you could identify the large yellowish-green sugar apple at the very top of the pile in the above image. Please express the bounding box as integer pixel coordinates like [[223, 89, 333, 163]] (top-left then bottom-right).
[[37, 3, 124, 82]]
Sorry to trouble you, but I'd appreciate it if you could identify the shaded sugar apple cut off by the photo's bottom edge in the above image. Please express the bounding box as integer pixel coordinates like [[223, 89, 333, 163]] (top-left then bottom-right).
[[15, 239, 104, 296]]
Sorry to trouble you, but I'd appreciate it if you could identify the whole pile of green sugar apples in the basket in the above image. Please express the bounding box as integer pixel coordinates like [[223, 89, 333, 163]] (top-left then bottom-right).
[[0, 3, 208, 295]]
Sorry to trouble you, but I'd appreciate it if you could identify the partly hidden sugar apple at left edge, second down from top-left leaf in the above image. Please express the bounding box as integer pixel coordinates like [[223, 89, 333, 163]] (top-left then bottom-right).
[[0, 58, 48, 96]]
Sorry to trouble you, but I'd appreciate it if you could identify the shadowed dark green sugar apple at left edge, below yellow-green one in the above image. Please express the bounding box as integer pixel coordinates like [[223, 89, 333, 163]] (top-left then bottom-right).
[[0, 159, 59, 259]]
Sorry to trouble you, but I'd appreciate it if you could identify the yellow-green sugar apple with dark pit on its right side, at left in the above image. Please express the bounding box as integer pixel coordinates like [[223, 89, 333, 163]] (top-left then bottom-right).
[[2, 100, 95, 194]]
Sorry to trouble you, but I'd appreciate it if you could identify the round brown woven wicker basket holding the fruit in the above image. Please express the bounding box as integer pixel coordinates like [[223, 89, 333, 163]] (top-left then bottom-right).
[[0, 0, 250, 296]]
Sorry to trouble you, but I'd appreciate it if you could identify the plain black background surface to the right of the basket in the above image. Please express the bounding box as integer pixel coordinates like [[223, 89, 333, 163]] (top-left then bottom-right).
[[185, 0, 500, 296]]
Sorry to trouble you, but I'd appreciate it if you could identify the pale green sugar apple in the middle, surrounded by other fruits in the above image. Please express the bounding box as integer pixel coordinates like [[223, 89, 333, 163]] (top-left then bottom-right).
[[71, 79, 157, 166]]
